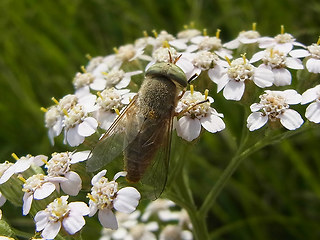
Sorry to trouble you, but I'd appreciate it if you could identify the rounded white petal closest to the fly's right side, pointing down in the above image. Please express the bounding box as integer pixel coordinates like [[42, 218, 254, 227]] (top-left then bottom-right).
[[176, 116, 201, 142]]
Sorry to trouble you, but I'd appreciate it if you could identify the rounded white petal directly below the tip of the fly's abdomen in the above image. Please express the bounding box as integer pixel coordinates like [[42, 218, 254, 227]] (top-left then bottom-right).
[[113, 187, 141, 213]]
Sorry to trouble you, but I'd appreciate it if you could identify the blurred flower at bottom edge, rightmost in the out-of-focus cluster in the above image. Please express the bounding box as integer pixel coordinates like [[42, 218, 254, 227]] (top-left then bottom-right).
[[159, 225, 193, 240]]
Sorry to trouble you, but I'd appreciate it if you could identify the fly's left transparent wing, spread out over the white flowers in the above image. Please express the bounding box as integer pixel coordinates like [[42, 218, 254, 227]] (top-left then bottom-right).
[[87, 95, 143, 172]]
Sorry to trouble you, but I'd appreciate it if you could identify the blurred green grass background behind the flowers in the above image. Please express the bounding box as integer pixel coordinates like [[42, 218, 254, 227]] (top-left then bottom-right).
[[0, 0, 320, 240]]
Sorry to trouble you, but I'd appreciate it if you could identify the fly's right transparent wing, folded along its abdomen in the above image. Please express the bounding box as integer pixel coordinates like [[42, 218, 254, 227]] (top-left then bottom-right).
[[141, 114, 172, 199]]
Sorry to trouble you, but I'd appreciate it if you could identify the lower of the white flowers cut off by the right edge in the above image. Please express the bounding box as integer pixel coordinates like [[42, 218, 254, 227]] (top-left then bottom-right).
[[301, 85, 320, 123]]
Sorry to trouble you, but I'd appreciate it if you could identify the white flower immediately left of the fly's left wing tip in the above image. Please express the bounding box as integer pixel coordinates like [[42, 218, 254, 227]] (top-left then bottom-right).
[[45, 151, 90, 196]]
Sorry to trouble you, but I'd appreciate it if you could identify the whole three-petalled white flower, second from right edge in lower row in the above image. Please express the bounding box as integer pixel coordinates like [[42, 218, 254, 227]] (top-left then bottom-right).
[[247, 90, 303, 131]]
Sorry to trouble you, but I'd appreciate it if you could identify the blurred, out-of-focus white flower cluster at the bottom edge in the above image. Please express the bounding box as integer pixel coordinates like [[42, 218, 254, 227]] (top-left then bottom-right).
[[100, 198, 193, 240]]
